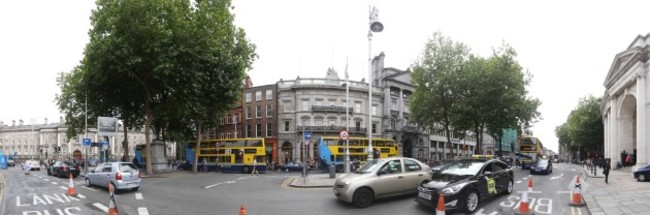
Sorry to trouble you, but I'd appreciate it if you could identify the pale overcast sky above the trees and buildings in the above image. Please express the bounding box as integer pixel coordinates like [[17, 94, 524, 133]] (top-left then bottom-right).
[[0, 0, 650, 151]]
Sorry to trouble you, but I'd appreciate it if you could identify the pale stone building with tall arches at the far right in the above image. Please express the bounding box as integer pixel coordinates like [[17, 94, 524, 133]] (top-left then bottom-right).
[[601, 34, 650, 167]]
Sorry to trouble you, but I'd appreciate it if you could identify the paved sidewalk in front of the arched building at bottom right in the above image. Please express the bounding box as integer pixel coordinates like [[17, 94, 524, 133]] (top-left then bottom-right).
[[574, 165, 650, 215]]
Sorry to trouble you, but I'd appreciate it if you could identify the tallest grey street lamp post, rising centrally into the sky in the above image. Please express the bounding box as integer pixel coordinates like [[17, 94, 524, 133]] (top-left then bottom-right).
[[366, 6, 384, 161]]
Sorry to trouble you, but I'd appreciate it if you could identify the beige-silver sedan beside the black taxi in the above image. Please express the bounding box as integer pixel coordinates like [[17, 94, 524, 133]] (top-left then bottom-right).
[[333, 157, 431, 208]]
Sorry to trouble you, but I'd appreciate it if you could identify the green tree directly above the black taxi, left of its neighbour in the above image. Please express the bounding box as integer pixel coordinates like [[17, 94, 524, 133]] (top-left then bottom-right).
[[409, 32, 470, 160]]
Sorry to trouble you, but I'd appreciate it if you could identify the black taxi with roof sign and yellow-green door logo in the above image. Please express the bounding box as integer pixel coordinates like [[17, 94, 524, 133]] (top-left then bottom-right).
[[416, 158, 514, 214]]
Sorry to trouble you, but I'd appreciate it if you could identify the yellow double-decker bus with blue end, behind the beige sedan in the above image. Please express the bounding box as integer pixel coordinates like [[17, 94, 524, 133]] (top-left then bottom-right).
[[318, 136, 399, 171]]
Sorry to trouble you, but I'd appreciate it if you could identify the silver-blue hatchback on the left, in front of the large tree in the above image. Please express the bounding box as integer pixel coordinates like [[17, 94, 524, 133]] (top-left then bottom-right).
[[86, 162, 141, 191]]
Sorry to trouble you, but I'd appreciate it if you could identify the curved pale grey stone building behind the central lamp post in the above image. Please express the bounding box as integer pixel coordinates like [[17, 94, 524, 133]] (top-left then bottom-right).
[[277, 68, 383, 161]]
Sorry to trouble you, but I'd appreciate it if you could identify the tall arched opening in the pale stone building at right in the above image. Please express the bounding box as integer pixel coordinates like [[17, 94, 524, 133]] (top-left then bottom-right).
[[618, 95, 637, 165]]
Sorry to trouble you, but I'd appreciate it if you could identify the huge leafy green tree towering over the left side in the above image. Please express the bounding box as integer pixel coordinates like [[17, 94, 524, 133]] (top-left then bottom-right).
[[57, 0, 256, 174]]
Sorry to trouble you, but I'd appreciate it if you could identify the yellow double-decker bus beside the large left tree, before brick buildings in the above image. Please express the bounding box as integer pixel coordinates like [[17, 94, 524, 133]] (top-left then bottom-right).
[[186, 138, 266, 173]]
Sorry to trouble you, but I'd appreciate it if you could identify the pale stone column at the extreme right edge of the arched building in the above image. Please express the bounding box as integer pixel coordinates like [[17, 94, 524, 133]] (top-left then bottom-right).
[[636, 69, 648, 167]]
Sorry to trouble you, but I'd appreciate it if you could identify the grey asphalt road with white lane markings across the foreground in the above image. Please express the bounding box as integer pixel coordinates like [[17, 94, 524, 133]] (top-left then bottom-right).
[[0, 164, 589, 215]]
